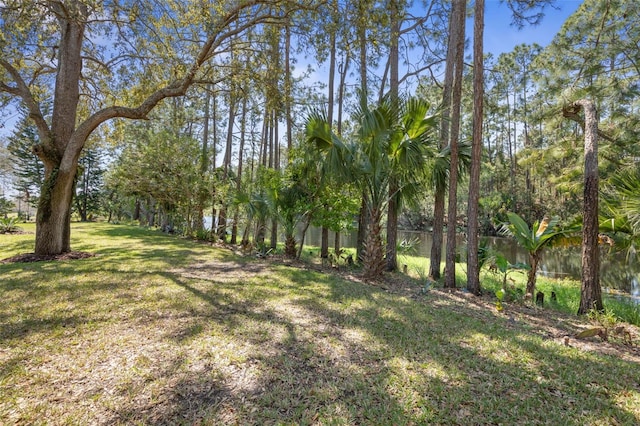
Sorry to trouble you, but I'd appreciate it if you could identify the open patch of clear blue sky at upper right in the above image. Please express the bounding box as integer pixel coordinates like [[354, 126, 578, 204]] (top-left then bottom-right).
[[482, 0, 582, 57]]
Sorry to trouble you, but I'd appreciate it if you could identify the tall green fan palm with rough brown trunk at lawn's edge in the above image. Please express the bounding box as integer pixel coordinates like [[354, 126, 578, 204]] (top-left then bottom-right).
[[306, 98, 435, 279]]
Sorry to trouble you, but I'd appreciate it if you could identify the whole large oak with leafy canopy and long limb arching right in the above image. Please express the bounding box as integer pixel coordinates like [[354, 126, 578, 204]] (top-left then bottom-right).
[[0, 0, 302, 255]]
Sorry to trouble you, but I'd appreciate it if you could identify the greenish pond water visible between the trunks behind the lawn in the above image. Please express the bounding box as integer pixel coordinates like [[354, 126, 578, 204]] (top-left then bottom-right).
[[305, 227, 640, 303]]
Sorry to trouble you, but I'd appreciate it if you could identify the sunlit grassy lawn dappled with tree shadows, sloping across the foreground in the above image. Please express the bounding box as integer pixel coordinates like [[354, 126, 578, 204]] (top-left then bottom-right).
[[0, 223, 640, 425]]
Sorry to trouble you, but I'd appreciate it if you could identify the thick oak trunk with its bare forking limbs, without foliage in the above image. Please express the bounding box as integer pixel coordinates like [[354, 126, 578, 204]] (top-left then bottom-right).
[[0, 0, 295, 255]]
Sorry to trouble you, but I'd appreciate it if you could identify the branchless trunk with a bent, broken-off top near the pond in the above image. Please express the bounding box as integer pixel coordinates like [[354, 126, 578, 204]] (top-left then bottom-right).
[[575, 100, 604, 314]]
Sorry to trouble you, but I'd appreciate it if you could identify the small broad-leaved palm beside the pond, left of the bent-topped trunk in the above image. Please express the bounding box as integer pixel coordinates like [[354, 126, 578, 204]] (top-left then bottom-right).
[[502, 212, 565, 300]]
